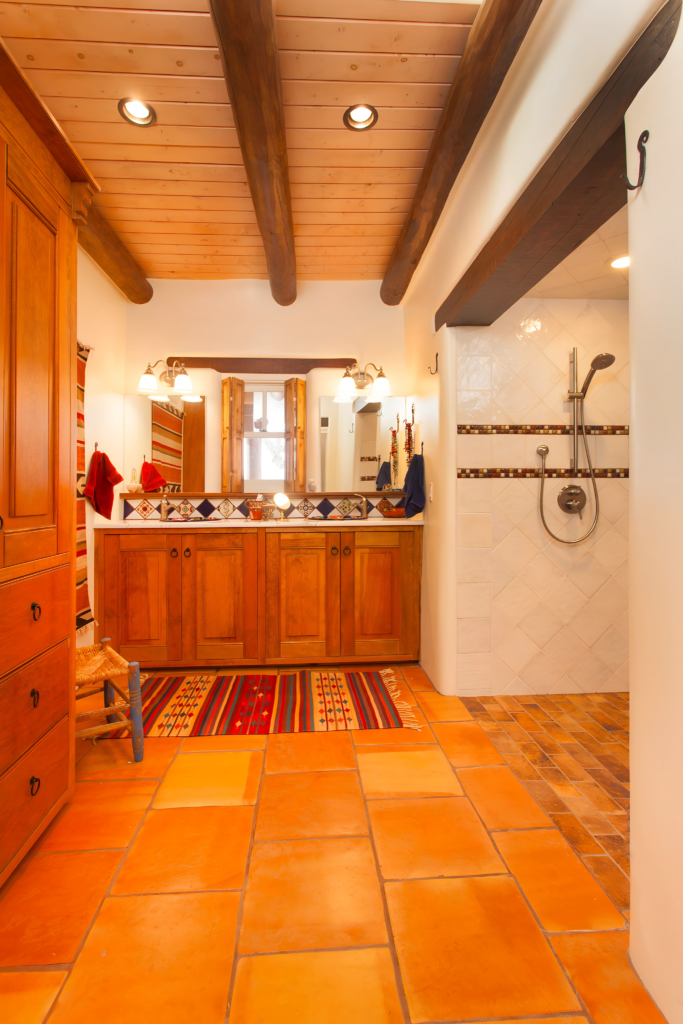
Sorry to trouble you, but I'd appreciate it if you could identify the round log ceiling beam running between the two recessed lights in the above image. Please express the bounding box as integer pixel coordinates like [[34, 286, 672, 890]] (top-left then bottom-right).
[[210, 0, 296, 306]]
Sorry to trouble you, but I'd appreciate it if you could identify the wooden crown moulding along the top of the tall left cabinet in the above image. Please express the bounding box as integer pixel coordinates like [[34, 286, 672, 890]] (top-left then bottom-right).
[[0, 40, 99, 191]]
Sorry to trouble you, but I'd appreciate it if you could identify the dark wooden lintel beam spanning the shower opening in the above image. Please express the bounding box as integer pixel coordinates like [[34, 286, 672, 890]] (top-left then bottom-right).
[[435, 0, 682, 331]]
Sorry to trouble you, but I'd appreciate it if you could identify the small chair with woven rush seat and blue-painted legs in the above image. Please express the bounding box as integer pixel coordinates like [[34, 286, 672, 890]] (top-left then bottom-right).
[[76, 637, 144, 761]]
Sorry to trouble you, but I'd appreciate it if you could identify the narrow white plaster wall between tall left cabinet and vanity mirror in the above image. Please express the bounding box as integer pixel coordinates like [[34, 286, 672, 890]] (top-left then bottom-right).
[[77, 249, 129, 646]]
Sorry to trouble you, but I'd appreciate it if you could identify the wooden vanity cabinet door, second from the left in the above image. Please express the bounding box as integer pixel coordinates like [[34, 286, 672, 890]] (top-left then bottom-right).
[[181, 530, 258, 664]]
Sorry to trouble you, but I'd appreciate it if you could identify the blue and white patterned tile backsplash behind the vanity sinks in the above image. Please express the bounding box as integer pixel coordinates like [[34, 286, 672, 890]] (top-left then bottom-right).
[[123, 489, 403, 522]]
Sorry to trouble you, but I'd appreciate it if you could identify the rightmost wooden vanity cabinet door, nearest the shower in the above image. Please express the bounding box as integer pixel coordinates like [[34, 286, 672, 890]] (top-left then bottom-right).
[[341, 528, 419, 657]]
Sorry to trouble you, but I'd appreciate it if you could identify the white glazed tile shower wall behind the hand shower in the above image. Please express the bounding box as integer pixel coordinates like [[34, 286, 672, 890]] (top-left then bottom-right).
[[456, 299, 629, 694]]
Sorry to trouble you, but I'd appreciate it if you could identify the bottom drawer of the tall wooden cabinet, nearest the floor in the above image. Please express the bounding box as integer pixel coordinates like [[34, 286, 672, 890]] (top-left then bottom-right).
[[0, 717, 69, 871]]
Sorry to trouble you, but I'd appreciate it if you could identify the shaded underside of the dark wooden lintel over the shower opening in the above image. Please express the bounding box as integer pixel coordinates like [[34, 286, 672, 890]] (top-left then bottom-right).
[[444, 123, 627, 327]]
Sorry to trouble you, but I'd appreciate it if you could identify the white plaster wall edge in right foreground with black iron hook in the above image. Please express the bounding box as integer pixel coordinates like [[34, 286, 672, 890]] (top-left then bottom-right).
[[627, 19, 683, 1024]]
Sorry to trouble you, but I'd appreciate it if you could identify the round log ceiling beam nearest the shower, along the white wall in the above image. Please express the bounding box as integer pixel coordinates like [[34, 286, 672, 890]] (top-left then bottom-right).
[[380, 0, 541, 306]]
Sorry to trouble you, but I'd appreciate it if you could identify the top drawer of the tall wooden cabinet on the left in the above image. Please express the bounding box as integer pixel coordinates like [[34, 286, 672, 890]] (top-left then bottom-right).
[[0, 565, 71, 672]]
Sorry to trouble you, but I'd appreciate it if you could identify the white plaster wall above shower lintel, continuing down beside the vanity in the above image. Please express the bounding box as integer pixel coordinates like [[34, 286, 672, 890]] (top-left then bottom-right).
[[403, 0, 661, 692]]
